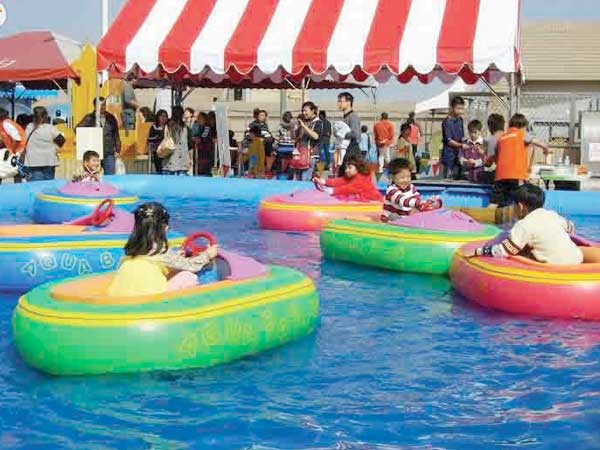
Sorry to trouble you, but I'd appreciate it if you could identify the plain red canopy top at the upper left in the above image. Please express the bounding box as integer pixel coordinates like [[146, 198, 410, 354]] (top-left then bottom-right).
[[0, 31, 81, 87]]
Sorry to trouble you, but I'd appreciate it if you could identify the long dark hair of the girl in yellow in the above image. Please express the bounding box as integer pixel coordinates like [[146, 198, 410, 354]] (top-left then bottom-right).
[[125, 202, 169, 257]]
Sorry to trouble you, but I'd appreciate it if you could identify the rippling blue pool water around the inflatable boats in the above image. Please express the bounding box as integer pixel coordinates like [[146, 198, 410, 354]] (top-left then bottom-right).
[[0, 199, 600, 450]]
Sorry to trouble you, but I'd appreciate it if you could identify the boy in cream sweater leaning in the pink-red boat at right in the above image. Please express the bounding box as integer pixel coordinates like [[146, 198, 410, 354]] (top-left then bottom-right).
[[469, 184, 583, 265]]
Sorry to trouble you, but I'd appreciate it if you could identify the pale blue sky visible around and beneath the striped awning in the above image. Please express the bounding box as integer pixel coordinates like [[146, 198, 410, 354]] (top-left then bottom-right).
[[0, 0, 600, 100]]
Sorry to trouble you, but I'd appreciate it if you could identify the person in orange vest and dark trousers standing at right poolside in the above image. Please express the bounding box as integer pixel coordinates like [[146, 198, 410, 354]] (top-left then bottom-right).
[[490, 114, 548, 207]]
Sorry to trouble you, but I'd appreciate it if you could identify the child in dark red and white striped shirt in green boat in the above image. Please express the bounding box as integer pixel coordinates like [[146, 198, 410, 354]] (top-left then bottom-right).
[[381, 158, 442, 222]]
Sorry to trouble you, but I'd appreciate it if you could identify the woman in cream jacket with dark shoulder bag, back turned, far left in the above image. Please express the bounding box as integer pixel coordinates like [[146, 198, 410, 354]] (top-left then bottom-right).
[[25, 106, 65, 181]]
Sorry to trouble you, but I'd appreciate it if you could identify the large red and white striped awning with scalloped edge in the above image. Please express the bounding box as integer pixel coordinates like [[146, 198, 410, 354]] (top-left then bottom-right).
[[98, 0, 521, 82]]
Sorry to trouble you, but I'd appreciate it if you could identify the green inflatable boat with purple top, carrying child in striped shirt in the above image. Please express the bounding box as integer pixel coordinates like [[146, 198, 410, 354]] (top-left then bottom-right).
[[321, 210, 500, 274]]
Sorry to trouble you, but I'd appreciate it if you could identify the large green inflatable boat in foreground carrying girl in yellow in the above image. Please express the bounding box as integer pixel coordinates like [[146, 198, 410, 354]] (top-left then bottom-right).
[[13, 252, 319, 375]]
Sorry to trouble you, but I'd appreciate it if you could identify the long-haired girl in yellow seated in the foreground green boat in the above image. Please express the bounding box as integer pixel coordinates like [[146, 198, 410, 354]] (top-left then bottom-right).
[[108, 202, 218, 297]]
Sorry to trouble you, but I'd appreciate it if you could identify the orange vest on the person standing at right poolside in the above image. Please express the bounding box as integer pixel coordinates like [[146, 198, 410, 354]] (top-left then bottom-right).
[[496, 128, 529, 181]]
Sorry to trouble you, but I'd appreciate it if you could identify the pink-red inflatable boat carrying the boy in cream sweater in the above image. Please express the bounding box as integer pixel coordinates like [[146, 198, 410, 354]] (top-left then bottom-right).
[[450, 237, 600, 320]]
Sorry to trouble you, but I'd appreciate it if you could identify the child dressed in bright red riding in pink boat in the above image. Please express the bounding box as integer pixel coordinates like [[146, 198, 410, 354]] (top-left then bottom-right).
[[313, 158, 381, 202]]
